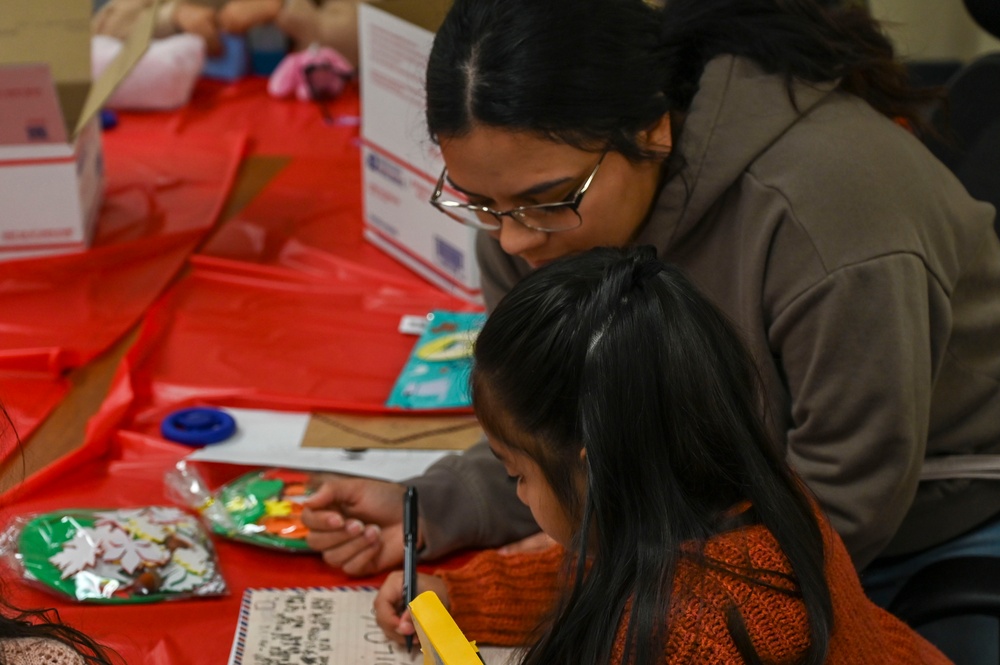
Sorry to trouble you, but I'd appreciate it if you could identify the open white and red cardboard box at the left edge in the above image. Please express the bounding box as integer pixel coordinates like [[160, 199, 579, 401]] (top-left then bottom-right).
[[0, 0, 156, 259]]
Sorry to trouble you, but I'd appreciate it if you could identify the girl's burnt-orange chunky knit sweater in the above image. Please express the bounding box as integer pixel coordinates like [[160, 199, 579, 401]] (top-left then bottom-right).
[[439, 520, 950, 665]]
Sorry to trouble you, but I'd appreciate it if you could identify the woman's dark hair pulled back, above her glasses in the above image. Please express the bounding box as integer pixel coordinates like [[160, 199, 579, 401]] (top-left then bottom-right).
[[426, 0, 938, 159]]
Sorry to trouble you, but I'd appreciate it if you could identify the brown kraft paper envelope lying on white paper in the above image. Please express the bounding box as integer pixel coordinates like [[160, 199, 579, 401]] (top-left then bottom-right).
[[302, 413, 483, 450]]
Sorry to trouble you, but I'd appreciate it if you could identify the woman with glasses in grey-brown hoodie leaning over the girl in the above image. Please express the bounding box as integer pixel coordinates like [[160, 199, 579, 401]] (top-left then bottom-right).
[[306, 0, 1000, 652]]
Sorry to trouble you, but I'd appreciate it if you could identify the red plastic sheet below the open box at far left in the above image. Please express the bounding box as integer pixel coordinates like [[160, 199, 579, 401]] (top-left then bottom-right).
[[0, 130, 245, 452]]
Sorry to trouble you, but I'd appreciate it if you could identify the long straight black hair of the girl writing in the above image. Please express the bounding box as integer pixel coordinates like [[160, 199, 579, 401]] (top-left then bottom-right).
[[472, 247, 832, 665]]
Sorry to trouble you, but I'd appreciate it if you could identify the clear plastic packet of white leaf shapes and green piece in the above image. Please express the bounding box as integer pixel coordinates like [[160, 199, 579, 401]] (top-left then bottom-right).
[[0, 506, 227, 604]]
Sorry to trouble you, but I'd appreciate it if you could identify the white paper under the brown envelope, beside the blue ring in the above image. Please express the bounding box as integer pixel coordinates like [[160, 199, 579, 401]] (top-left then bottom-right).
[[188, 407, 454, 482]]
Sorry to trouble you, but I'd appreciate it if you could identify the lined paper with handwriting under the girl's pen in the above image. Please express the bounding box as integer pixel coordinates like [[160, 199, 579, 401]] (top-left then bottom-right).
[[229, 588, 516, 665]]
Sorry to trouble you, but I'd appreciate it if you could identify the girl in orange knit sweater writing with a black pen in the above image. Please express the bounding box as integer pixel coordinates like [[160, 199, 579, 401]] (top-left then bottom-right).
[[376, 248, 949, 665]]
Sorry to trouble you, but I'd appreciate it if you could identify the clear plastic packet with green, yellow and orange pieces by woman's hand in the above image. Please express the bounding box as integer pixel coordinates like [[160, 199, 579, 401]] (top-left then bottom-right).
[[165, 461, 312, 552]]
